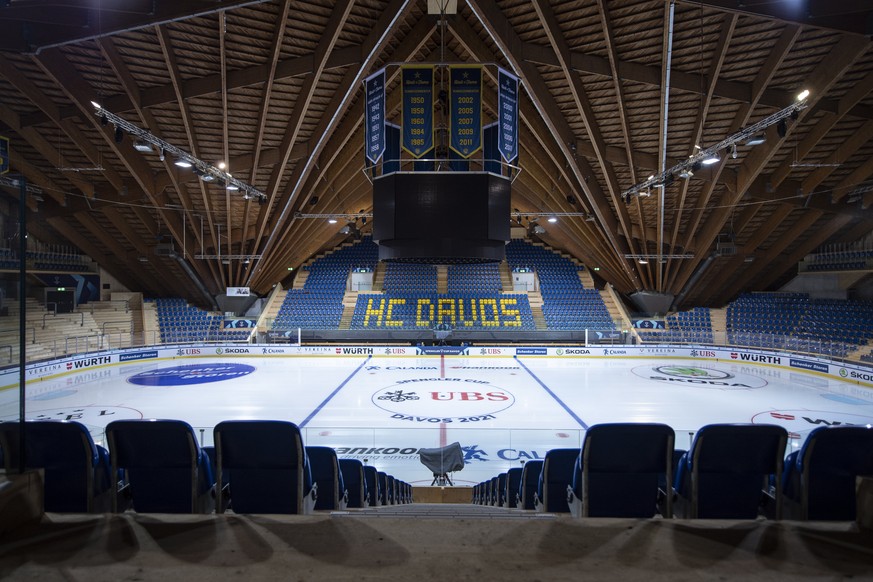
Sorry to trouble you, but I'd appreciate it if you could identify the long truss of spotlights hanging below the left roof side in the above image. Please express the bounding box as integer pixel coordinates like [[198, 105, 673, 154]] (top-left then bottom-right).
[[91, 101, 267, 204]]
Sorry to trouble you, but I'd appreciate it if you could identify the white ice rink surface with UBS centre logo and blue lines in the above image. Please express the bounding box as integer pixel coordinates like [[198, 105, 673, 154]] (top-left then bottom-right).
[[0, 356, 873, 485]]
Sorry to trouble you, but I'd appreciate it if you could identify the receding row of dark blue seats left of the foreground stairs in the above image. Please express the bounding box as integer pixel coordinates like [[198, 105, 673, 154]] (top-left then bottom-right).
[[0, 419, 412, 514]]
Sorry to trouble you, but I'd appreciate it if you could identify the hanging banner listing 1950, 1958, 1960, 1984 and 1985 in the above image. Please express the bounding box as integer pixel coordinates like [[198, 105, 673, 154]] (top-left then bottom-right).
[[400, 65, 433, 158]]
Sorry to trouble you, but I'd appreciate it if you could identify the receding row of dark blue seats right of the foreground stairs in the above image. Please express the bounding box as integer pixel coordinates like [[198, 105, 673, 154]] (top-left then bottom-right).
[[473, 423, 873, 520]]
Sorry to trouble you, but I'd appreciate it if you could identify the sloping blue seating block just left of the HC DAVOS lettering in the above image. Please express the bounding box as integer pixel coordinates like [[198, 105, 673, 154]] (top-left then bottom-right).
[[273, 237, 379, 330]]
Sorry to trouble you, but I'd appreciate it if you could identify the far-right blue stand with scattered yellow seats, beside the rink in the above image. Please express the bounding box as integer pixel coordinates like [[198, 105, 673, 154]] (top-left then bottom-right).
[[727, 293, 873, 358]]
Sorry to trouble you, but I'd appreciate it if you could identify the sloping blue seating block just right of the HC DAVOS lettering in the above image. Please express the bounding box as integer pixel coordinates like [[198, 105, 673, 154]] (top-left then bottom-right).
[[506, 239, 616, 331]]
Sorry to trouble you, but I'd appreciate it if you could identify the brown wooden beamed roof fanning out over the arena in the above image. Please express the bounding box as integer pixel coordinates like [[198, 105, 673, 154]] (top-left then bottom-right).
[[0, 0, 873, 308]]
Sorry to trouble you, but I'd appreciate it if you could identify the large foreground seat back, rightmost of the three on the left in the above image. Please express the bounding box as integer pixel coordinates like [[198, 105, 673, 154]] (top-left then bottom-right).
[[214, 420, 317, 514]]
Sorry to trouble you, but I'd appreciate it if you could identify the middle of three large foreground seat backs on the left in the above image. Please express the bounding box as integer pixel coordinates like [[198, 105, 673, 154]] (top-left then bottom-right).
[[106, 419, 215, 513]]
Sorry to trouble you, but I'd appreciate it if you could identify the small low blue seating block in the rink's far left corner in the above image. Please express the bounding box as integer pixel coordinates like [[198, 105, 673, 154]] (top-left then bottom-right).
[[154, 298, 252, 343]]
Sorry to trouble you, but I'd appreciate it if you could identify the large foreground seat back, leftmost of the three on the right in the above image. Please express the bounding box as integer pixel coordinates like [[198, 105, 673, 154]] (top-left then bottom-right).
[[567, 423, 675, 517]]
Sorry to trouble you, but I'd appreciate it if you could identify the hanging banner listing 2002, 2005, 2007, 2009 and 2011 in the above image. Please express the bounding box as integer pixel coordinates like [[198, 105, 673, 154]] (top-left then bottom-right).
[[449, 66, 482, 158]]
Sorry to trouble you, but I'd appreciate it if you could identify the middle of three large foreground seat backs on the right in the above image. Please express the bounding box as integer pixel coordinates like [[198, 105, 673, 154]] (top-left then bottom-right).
[[674, 424, 788, 519]]
